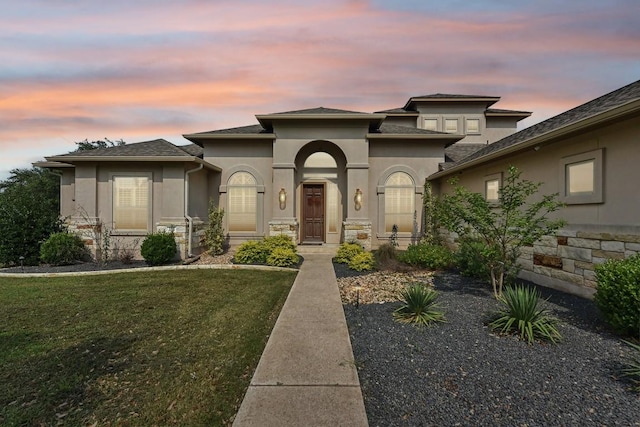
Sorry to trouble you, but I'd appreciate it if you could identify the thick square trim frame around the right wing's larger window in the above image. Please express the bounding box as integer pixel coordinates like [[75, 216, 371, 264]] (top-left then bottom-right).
[[558, 148, 604, 205]]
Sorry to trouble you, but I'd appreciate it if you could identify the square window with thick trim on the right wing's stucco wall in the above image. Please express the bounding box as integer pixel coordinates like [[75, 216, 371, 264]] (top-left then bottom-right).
[[560, 149, 604, 204]]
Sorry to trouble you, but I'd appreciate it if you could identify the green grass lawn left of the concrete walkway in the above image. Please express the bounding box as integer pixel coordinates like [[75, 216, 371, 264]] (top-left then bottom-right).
[[0, 270, 295, 425]]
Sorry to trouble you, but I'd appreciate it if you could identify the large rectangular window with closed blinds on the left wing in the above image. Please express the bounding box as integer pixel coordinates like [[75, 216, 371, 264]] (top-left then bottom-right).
[[113, 176, 151, 231]]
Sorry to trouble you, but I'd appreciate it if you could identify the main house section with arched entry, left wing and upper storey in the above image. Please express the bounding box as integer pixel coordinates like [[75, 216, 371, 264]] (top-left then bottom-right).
[[36, 94, 530, 257]]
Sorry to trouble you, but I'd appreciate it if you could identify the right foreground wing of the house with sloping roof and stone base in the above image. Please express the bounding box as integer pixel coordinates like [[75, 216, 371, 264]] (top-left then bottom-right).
[[428, 81, 640, 297]]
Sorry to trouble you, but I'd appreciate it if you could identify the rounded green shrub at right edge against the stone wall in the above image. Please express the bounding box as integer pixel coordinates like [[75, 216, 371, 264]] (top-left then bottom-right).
[[594, 254, 640, 337]]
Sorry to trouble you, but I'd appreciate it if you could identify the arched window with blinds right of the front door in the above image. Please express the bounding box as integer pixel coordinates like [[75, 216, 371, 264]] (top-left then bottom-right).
[[384, 172, 416, 233]]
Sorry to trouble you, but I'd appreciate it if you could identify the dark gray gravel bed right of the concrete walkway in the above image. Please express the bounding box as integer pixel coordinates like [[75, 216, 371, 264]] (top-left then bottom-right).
[[336, 268, 640, 426]]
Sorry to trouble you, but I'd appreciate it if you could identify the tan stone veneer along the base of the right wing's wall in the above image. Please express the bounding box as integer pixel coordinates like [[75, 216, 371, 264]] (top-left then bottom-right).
[[446, 227, 640, 298]]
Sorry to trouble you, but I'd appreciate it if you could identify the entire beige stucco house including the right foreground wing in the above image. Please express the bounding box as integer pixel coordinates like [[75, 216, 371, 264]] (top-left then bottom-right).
[[36, 81, 640, 296]]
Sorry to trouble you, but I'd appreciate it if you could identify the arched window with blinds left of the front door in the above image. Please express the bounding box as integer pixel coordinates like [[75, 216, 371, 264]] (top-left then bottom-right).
[[227, 172, 258, 232]]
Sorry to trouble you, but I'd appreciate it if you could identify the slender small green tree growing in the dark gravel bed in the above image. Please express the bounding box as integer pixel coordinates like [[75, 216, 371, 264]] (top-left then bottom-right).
[[439, 166, 564, 298]]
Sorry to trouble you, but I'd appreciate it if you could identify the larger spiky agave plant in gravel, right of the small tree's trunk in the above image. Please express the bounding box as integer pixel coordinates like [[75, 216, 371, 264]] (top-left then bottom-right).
[[489, 286, 562, 344]]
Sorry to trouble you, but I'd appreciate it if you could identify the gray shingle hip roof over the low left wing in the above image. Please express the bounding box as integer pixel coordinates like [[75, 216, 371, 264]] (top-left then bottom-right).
[[52, 139, 202, 158]]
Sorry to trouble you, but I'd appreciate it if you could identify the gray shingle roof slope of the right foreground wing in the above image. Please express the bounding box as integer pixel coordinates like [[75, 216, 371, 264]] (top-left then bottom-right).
[[448, 80, 640, 171]]
